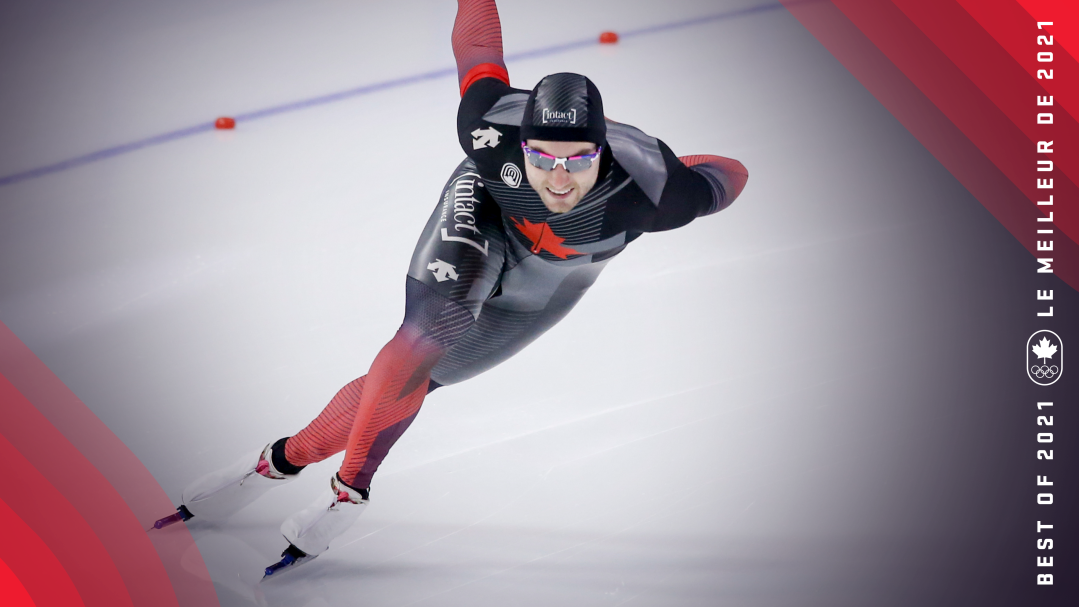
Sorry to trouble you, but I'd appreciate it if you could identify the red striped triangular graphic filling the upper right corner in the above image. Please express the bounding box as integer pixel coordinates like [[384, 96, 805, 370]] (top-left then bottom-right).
[[783, 0, 1079, 289]]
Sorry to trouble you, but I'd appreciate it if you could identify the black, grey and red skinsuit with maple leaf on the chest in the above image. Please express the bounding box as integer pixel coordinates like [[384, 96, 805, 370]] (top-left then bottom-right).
[[273, 0, 747, 488]]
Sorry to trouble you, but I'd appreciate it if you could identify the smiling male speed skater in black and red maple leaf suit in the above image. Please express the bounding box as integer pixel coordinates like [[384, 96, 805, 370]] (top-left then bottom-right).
[[159, 0, 748, 575]]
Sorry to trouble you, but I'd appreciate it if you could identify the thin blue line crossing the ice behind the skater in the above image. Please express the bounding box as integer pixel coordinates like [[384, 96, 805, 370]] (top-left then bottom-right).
[[0, 0, 794, 187]]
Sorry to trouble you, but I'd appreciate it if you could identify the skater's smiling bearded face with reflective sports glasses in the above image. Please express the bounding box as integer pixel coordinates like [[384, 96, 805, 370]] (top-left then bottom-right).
[[524, 139, 600, 212]]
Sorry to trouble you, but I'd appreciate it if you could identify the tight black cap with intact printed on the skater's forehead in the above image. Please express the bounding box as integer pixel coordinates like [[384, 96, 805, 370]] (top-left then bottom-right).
[[521, 73, 606, 146]]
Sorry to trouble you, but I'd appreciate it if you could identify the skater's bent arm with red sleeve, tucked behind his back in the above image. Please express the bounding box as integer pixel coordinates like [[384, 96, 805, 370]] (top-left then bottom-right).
[[648, 141, 749, 232]]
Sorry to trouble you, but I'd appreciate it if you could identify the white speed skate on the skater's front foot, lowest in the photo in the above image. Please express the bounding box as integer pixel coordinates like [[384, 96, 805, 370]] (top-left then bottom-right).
[[265, 474, 370, 577]]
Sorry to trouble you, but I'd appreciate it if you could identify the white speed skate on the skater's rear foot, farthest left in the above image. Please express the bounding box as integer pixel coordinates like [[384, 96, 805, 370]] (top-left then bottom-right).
[[153, 441, 299, 529]]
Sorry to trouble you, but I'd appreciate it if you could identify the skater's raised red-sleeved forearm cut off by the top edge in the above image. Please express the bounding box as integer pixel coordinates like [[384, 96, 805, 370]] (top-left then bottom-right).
[[452, 0, 509, 97]]
